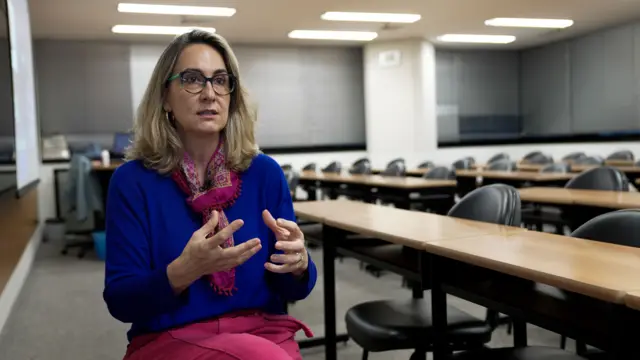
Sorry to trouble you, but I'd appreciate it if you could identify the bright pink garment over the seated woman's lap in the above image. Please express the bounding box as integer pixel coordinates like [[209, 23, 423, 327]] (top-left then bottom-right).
[[124, 312, 313, 360]]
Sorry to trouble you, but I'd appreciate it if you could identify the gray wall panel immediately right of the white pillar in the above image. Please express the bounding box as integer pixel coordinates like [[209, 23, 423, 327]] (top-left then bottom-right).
[[436, 49, 520, 141]]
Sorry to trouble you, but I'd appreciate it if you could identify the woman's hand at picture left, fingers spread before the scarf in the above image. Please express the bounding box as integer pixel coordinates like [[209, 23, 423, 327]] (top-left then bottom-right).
[[167, 211, 262, 294]]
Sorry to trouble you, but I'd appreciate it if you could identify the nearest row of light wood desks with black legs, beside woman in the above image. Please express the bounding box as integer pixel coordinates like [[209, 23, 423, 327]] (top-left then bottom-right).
[[294, 200, 640, 360]]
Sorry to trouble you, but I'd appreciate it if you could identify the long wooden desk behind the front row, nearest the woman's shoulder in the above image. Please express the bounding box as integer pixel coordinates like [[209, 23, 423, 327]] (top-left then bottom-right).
[[300, 171, 456, 209]]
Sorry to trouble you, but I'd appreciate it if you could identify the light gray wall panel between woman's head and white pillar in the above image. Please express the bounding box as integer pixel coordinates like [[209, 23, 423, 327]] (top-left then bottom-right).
[[234, 45, 366, 147]]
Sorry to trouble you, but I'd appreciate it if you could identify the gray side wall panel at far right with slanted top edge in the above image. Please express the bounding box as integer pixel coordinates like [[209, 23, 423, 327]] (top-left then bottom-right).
[[521, 23, 640, 135]]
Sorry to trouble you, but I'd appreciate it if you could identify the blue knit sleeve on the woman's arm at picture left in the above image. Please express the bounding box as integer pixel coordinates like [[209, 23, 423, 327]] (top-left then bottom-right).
[[103, 163, 188, 322]]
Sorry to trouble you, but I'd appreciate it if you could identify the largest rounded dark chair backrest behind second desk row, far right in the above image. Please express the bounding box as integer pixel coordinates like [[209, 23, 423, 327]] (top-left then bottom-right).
[[565, 166, 629, 191]]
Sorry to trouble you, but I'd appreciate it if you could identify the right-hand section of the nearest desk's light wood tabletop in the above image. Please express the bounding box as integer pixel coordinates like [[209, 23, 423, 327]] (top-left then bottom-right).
[[425, 231, 640, 304]]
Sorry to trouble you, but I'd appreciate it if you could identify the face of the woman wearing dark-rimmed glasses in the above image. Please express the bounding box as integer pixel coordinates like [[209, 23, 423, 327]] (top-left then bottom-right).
[[164, 44, 233, 135]]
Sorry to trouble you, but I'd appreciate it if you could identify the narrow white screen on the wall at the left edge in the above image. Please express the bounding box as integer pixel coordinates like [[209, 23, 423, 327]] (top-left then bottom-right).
[[7, 0, 40, 192]]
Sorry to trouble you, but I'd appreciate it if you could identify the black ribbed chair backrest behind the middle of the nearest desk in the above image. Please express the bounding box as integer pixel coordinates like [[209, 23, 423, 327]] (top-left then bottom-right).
[[448, 184, 521, 226]]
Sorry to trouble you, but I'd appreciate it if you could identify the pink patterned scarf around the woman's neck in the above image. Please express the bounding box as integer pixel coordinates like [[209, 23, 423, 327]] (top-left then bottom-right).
[[172, 138, 242, 296]]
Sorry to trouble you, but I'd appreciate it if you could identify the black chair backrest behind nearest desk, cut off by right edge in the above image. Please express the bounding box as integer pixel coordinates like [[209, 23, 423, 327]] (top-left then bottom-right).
[[571, 209, 640, 247]]
